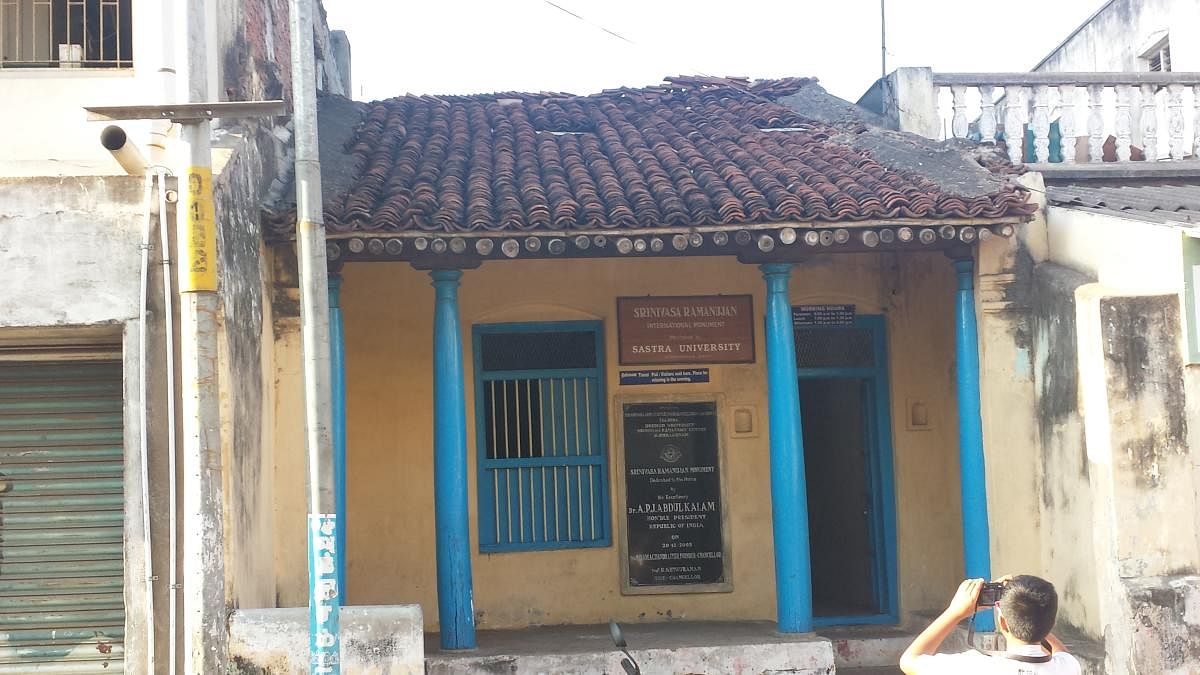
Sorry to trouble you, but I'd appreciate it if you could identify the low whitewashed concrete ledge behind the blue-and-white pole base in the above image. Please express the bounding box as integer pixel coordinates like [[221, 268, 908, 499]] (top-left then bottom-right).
[[229, 604, 425, 675]]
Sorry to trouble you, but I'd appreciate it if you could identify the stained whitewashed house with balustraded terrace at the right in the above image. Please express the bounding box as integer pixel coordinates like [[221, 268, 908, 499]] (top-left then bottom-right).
[[876, 0, 1200, 673]]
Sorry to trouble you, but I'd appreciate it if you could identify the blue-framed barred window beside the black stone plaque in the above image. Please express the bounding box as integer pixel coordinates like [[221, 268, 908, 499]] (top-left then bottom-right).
[[474, 322, 611, 552]]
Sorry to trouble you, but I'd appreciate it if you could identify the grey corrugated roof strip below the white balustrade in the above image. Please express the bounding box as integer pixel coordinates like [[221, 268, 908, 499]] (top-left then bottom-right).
[[1046, 183, 1200, 228]]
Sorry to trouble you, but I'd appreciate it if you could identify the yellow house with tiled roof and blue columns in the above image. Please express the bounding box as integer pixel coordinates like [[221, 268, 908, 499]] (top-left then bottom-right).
[[232, 78, 1037, 673]]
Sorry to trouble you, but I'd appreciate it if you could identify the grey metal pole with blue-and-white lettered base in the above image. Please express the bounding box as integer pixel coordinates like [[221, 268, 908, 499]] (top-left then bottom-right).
[[288, 0, 341, 674]]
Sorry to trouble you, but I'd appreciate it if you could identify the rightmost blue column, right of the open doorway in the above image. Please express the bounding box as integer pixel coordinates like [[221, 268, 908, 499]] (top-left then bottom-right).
[[954, 258, 994, 631]]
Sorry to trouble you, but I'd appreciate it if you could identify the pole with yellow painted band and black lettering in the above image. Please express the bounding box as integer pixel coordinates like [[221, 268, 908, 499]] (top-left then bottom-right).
[[176, 0, 228, 673]]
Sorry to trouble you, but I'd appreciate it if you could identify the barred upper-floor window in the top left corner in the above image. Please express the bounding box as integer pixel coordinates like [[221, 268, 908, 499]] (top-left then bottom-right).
[[0, 0, 133, 68]]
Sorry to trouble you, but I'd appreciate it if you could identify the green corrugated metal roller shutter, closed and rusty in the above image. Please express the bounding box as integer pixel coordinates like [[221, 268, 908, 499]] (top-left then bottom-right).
[[0, 362, 125, 674]]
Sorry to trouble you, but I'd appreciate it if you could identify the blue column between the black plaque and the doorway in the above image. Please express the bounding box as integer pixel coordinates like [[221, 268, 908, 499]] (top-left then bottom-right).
[[760, 263, 812, 633]]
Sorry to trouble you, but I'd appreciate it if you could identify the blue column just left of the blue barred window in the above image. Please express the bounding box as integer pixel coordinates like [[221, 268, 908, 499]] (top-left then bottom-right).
[[430, 269, 475, 650]]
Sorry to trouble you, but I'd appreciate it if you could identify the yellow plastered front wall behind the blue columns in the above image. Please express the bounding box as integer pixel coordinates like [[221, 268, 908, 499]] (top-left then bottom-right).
[[275, 253, 961, 628]]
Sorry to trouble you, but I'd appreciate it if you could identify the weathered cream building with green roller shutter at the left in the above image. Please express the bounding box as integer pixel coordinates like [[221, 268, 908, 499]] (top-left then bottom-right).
[[0, 0, 348, 673]]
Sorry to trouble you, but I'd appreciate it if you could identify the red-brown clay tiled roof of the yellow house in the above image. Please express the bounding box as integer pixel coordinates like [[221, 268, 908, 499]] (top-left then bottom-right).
[[271, 78, 1034, 234]]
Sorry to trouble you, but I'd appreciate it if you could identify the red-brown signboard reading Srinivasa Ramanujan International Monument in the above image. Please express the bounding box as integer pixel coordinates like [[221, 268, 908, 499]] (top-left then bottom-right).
[[617, 295, 754, 365]]
